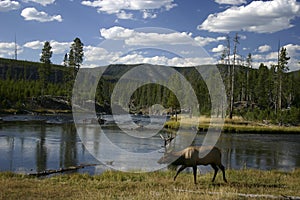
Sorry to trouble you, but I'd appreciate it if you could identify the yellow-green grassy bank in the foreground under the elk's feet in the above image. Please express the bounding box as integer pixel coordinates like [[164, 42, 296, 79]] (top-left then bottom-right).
[[0, 169, 300, 199]]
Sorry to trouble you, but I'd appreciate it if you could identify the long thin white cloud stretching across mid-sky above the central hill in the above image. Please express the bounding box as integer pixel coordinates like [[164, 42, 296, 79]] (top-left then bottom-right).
[[100, 26, 226, 46]]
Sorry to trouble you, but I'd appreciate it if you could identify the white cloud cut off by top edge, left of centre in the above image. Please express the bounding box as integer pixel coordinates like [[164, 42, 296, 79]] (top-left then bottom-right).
[[81, 0, 176, 18]]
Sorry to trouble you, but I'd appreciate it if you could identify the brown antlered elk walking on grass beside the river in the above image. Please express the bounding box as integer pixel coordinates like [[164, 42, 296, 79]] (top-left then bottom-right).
[[158, 136, 227, 184]]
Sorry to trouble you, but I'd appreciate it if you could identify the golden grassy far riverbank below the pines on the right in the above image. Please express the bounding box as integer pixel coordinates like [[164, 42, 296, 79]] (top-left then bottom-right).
[[164, 115, 300, 134]]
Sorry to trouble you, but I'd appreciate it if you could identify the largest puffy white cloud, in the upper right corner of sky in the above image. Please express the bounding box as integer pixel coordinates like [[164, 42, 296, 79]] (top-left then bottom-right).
[[198, 0, 300, 33]]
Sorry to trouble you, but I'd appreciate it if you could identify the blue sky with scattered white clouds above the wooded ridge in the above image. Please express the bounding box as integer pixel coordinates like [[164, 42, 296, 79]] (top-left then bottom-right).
[[0, 0, 300, 71]]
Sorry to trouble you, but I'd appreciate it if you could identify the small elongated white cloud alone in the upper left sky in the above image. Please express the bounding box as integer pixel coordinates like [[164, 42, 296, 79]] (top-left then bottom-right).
[[21, 7, 62, 22]]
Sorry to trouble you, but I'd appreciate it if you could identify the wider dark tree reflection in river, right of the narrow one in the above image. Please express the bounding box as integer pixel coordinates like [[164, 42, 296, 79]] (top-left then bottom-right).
[[59, 124, 78, 167]]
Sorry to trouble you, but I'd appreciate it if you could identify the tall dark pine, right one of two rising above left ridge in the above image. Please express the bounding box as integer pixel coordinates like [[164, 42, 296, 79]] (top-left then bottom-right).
[[69, 37, 84, 76]]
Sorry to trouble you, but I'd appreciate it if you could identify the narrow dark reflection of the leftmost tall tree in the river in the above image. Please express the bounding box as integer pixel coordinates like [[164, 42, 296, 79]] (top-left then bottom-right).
[[36, 124, 47, 172]]
